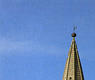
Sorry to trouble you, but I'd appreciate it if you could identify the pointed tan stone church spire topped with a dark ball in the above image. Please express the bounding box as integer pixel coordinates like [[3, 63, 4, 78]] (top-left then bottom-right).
[[63, 33, 84, 80]]
